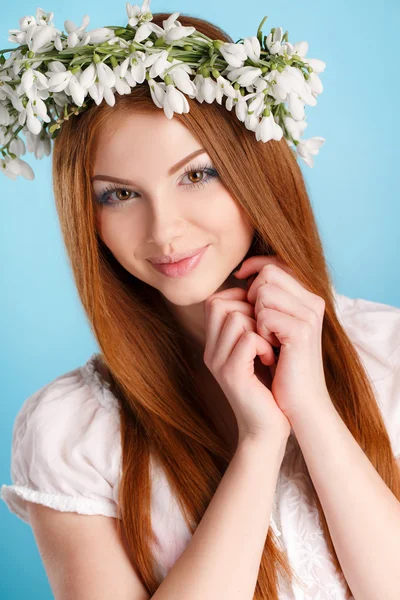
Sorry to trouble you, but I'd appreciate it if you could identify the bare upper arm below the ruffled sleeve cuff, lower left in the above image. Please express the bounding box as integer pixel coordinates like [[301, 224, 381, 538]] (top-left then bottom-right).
[[27, 502, 150, 600]]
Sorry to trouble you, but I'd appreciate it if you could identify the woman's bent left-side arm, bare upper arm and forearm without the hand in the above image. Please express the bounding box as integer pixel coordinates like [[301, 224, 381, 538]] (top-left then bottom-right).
[[28, 434, 287, 600]]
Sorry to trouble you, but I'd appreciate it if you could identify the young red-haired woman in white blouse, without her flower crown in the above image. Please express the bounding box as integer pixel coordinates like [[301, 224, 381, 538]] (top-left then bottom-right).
[[2, 5, 400, 600]]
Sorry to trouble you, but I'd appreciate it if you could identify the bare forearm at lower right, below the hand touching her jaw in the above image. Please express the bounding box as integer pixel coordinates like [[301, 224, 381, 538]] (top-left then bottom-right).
[[290, 401, 400, 600]]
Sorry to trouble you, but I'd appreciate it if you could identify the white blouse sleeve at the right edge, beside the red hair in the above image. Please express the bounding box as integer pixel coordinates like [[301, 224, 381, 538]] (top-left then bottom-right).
[[334, 292, 400, 458]]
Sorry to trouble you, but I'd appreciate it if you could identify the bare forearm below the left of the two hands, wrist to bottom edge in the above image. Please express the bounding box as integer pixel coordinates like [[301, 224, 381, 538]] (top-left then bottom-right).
[[152, 436, 287, 600]]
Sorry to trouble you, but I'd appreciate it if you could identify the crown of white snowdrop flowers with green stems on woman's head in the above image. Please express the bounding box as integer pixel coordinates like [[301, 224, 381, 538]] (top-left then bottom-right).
[[0, 0, 326, 180]]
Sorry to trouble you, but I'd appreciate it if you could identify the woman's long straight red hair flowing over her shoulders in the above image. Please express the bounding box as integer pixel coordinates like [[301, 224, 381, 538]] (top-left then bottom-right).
[[53, 13, 400, 600]]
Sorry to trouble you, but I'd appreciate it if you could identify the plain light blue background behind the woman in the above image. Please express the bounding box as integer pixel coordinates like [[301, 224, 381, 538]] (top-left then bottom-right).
[[0, 0, 400, 600]]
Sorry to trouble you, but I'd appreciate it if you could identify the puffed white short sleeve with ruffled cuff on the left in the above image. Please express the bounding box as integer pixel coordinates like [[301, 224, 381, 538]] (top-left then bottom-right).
[[1, 358, 121, 523]]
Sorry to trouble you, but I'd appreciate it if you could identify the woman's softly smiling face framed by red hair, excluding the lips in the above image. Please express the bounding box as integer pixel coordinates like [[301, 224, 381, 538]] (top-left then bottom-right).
[[93, 110, 254, 307]]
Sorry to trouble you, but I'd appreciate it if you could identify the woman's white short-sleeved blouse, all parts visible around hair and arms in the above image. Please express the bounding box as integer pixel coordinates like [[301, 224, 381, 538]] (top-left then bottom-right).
[[1, 292, 400, 600]]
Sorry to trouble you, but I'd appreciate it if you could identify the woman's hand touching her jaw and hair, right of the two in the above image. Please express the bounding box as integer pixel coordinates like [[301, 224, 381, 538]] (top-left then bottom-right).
[[234, 256, 331, 421]]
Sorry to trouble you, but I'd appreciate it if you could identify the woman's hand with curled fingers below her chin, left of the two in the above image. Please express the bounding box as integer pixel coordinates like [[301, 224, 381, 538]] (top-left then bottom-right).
[[204, 288, 291, 442]]
